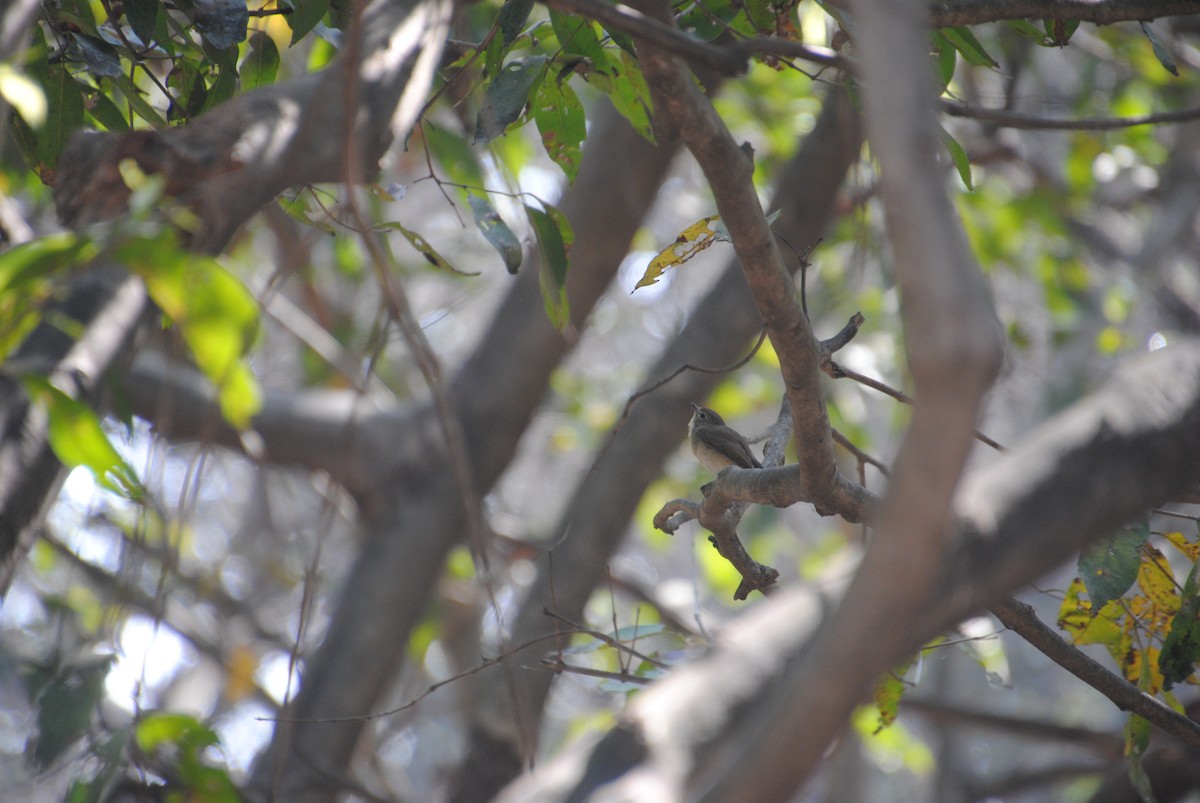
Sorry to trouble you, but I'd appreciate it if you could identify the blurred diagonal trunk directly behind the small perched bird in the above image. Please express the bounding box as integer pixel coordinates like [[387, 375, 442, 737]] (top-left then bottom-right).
[[455, 82, 862, 802]]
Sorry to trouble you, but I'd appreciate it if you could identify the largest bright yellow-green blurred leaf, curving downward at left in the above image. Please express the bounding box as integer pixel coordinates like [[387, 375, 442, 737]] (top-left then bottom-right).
[[115, 236, 262, 430]]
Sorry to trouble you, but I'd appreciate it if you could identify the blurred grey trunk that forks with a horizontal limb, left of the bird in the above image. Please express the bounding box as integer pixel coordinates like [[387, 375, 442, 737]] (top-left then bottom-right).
[[246, 103, 670, 801]]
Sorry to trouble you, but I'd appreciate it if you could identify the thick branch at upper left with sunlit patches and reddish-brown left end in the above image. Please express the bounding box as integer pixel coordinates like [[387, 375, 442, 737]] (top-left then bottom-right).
[[54, 0, 451, 253]]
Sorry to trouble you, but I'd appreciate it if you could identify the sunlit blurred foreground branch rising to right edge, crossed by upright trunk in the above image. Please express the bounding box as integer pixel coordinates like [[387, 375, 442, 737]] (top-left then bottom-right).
[[503, 341, 1200, 801]]
